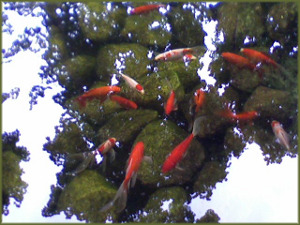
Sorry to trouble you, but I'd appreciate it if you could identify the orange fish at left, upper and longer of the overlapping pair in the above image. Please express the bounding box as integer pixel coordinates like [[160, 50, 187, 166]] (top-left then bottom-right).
[[76, 86, 121, 107]]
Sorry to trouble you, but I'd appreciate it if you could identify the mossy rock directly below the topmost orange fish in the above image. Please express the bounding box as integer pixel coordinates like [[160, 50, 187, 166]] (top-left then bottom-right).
[[121, 11, 172, 47]]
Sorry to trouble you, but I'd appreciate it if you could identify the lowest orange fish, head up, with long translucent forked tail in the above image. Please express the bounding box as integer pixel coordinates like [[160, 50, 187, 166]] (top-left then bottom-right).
[[100, 142, 144, 212]]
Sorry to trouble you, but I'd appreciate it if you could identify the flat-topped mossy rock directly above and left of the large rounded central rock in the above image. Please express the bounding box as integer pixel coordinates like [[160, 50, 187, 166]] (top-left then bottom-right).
[[97, 109, 158, 143]]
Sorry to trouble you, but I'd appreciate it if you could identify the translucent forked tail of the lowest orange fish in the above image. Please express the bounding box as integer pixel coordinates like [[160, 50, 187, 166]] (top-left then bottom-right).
[[100, 182, 128, 212]]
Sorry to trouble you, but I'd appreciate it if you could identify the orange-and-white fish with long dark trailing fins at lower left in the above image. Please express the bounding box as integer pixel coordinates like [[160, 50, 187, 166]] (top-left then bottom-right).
[[66, 138, 116, 175]]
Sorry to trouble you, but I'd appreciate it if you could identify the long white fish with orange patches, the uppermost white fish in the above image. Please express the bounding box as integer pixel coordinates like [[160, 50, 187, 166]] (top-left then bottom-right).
[[154, 48, 196, 61]]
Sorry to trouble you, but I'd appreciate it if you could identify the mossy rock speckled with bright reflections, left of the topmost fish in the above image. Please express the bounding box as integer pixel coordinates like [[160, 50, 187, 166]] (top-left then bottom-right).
[[78, 2, 126, 41]]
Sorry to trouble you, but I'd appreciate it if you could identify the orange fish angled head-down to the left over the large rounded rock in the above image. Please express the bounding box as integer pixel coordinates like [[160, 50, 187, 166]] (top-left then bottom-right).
[[162, 117, 204, 173]]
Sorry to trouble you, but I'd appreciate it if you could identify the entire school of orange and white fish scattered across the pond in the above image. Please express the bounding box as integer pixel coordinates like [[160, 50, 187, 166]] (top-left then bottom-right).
[[70, 4, 290, 212]]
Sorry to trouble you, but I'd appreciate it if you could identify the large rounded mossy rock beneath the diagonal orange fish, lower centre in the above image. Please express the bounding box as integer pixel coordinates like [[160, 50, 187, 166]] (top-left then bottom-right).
[[135, 120, 205, 187]]
